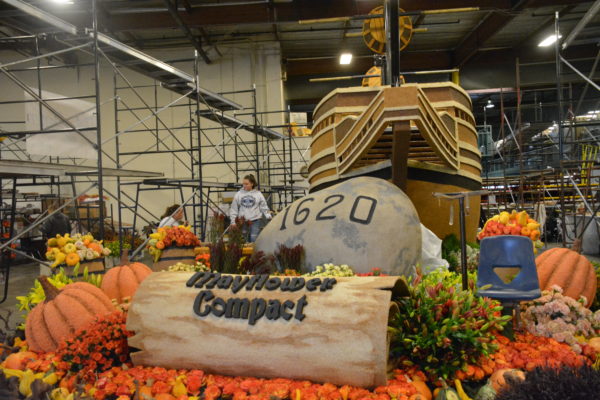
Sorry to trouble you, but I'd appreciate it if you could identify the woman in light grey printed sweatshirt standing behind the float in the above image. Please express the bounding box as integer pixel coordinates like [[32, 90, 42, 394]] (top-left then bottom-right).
[[229, 174, 271, 243]]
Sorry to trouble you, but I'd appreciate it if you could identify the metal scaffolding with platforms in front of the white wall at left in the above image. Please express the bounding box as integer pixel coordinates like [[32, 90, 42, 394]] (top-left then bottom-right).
[[0, 0, 306, 290]]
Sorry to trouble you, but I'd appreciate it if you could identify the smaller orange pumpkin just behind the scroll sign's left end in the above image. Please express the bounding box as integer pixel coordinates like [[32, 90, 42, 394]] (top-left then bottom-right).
[[102, 251, 152, 304]]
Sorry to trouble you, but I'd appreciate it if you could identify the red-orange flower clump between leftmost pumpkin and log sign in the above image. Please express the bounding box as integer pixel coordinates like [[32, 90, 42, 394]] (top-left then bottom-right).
[[57, 311, 133, 381]]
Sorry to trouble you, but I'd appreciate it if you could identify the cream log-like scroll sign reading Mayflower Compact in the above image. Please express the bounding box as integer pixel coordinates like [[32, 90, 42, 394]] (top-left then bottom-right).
[[127, 272, 408, 387]]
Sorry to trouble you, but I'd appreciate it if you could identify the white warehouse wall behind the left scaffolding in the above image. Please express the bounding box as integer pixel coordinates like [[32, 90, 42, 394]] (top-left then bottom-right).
[[0, 42, 310, 231]]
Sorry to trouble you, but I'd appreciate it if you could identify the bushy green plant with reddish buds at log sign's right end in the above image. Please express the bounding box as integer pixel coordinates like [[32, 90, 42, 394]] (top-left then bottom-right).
[[390, 271, 510, 379]]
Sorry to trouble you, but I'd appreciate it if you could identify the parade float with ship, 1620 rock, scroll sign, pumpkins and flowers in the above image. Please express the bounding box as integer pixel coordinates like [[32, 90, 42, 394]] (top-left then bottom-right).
[[0, 5, 600, 400]]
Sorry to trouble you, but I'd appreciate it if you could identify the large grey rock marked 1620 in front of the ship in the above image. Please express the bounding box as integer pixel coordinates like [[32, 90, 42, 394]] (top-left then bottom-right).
[[256, 177, 421, 276]]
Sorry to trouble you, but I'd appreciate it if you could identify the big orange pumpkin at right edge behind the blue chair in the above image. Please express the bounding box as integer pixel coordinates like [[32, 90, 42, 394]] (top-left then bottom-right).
[[535, 247, 598, 307]]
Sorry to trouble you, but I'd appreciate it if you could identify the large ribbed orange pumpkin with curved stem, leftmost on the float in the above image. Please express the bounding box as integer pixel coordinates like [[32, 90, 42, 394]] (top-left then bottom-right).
[[25, 276, 115, 352]]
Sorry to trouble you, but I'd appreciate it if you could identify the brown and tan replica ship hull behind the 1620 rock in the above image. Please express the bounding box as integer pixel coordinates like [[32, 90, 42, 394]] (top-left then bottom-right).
[[308, 82, 481, 240]]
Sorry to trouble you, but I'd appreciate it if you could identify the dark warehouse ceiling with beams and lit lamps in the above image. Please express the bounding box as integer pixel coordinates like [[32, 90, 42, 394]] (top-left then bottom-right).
[[0, 0, 600, 126]]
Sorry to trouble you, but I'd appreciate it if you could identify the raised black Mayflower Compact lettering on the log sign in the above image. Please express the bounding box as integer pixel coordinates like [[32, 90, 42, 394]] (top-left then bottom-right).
[[185, 272, 337, 325]]
